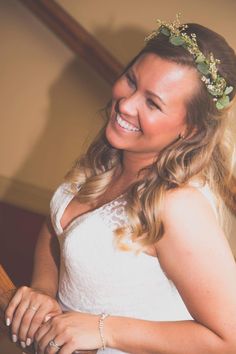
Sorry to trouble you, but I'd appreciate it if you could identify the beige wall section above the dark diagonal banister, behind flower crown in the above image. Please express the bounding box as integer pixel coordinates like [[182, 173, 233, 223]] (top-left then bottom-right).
[[56, 0, 236, 63]]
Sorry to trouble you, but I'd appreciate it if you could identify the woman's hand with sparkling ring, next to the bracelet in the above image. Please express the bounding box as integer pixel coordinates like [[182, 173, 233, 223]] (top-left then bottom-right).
[[35, 312, 101, 354]]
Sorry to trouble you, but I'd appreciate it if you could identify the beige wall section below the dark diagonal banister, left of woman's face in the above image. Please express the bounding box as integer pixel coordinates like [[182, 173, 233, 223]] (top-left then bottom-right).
[[0, 0, 110, 194]]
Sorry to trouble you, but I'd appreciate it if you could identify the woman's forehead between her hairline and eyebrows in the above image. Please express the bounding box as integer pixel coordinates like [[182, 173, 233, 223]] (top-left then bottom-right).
[[131, 53, 199, 105]]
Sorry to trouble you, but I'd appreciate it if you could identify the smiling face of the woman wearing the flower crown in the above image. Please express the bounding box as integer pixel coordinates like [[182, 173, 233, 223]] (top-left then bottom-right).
[[106, 54, 197, 156]]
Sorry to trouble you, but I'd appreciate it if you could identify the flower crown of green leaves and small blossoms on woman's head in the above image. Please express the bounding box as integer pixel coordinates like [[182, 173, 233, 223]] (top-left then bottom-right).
[[145, 14, 234, 110]]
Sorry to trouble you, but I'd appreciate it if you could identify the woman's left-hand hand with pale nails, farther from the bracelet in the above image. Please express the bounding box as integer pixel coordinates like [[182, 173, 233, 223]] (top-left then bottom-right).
[[5, 286, 62, 348]]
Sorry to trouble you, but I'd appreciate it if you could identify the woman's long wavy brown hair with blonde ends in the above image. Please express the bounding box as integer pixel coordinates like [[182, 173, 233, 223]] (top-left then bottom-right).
[[66, 24, 236, 249]]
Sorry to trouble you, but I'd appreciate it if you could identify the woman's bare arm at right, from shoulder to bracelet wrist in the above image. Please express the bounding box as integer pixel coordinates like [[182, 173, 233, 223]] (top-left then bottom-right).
[[105, 188, 236, 354]]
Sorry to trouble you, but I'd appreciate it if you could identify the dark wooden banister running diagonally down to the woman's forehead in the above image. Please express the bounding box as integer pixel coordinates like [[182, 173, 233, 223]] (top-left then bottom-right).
[[19, 0, 122, 84]]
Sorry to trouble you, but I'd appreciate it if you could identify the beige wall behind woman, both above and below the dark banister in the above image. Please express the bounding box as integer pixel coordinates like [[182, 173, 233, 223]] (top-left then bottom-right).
[[0, 0, 236, 249]]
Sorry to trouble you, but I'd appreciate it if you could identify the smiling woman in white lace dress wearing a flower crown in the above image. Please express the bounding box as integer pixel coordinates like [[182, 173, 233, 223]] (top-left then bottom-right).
[[3, 18, 236, 354]]
